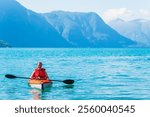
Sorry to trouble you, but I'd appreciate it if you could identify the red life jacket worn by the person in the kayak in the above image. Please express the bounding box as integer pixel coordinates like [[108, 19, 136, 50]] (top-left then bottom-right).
[[31, 68, 48, 80]]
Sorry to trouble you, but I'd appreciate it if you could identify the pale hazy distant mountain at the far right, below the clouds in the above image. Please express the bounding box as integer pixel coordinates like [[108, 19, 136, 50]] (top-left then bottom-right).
[[108, 19, 150, 47]]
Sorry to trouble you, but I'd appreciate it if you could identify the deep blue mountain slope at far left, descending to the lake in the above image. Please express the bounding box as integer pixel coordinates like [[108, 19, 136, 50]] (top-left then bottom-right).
[[0, 0, 70, 47]]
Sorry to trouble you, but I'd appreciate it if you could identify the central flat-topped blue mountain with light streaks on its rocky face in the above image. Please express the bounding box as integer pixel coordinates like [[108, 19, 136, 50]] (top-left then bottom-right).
[[42, 11, 134, 47]]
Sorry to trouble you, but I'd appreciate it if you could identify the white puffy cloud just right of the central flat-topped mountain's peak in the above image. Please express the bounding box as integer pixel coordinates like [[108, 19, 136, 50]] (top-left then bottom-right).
[[102, 8, 134, 22]]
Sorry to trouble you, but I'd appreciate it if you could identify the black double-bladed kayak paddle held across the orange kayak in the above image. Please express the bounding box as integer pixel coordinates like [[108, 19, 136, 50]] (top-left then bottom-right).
[[5, 74, 74, 84]]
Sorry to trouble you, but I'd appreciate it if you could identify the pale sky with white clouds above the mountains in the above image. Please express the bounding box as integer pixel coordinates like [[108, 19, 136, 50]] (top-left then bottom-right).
[[17, 0, 150, 22]]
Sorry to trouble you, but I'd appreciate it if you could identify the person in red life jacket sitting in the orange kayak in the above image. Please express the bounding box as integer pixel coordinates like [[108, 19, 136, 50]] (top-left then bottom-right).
[[30, 62, 49, 80]]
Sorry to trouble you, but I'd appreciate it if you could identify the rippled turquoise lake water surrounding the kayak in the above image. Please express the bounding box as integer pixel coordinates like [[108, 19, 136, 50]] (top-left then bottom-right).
[[0, 48, 150, 100]]
